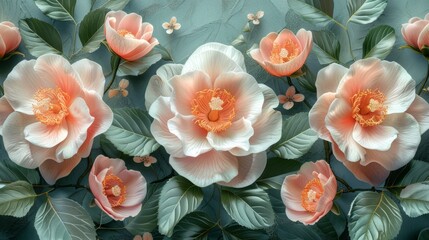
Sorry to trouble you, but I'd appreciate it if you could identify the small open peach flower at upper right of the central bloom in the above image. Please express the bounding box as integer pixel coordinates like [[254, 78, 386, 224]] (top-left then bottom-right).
[[250, 29, 313, 77]]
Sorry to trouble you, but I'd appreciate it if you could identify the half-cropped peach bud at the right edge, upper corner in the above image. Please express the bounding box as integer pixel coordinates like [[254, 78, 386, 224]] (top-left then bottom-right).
[[401, 13, 429, 50]]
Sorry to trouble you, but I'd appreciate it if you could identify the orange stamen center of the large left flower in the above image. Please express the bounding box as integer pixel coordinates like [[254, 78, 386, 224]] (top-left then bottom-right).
[[33, 87, 70, 126]]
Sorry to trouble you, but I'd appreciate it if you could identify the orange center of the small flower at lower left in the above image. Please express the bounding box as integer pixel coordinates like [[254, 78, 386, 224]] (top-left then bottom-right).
[[103, 174, 127, 207]]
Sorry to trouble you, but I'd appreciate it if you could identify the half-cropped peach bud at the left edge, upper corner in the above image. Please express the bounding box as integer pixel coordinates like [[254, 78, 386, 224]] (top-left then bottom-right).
[[0, 21, 21, 58]]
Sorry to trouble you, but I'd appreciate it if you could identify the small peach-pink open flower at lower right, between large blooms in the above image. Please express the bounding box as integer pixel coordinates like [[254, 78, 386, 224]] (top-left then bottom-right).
[[280, 160, 337, 225]]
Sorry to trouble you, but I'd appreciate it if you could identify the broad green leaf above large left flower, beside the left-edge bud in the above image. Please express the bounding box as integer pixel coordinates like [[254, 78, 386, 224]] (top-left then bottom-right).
[[19, 18, 63, 57]]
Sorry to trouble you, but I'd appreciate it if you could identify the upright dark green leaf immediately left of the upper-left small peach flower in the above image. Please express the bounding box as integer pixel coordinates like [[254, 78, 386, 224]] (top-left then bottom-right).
[[79, 8, 109, 53]]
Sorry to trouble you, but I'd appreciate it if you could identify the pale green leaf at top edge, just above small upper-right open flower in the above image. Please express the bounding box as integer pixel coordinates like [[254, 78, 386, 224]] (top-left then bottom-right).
[[288, 0, 338, 27]]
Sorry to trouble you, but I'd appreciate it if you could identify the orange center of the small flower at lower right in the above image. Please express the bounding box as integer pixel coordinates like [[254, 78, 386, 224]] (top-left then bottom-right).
[[301, 178, 324, 212]]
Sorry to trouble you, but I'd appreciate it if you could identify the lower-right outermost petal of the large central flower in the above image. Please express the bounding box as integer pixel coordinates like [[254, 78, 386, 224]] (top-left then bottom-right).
[[218, 152, 267, 188]]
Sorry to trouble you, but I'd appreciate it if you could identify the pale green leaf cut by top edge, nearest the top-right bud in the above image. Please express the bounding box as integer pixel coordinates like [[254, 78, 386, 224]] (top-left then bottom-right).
[[347, 0, 387, 24]]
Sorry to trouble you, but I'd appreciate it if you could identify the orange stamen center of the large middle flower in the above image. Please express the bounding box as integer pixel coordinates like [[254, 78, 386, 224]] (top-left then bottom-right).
[[191, 88, 235, 132]]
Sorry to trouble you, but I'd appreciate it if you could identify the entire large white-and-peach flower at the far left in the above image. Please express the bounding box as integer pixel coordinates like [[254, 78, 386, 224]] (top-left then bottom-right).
[[0, 54, 113, 184]]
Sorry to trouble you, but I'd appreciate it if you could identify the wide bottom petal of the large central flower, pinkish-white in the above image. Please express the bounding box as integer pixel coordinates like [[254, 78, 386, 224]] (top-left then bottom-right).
[[170, 151, 239, 187]]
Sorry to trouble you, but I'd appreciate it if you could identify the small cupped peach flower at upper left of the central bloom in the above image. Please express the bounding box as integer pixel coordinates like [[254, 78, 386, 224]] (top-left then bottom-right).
[[104, 11, 158, 61]]
